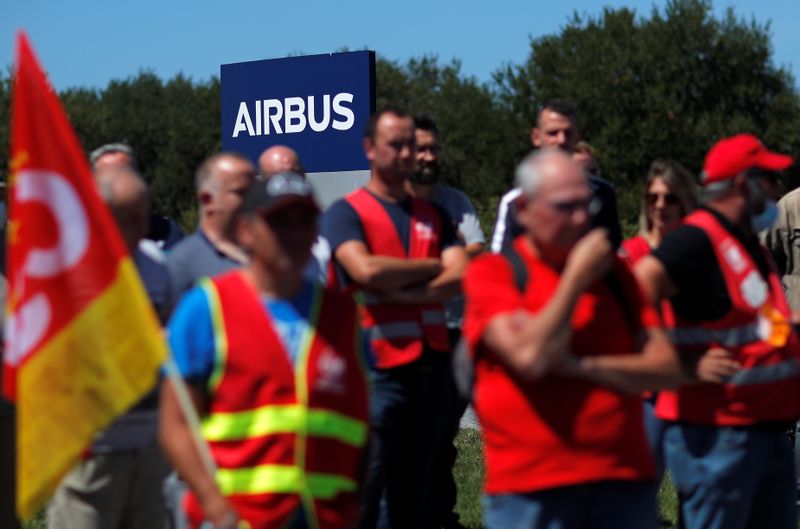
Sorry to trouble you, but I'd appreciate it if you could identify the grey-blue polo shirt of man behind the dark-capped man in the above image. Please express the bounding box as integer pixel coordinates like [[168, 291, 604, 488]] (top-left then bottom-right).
[[167, 230, 242, 302]]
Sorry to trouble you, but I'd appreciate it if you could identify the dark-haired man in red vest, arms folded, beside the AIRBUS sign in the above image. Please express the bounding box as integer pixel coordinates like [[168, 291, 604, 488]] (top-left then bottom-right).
[[323, 110, 466, 529]]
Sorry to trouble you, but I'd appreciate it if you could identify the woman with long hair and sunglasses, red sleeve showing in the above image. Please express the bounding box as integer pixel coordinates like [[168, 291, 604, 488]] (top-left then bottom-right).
[[621, 160, 697, 264]]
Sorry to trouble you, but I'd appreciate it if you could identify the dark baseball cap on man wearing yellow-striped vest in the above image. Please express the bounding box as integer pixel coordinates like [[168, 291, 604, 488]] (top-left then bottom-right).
[[242, 172, 319, 214]]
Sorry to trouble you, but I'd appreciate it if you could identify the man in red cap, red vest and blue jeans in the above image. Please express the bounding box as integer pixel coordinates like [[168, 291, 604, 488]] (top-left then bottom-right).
[[635, 134, 800, 529]]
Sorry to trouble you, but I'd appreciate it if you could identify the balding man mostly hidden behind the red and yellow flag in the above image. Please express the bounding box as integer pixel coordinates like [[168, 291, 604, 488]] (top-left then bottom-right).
[[47, 165, 172, 529]]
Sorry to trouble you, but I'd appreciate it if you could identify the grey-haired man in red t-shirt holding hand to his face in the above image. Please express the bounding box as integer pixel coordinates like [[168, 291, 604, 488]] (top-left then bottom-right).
[[464, 150, 680, 529]]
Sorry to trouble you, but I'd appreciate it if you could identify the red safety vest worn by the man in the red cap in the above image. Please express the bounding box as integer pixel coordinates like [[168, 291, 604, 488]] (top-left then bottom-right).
[[656, 210, 800, 426]]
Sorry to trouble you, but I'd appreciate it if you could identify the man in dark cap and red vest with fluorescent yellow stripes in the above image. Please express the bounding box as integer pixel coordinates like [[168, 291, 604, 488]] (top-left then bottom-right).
[[161, 173, 369, 529]]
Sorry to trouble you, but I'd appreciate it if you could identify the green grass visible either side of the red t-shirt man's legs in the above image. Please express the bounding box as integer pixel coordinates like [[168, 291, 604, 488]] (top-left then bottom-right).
[[453, 428, 678, 529]]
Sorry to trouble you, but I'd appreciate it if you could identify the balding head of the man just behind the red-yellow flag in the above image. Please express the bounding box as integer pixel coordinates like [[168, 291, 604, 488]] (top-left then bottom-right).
[[95, 165, 149, 252]]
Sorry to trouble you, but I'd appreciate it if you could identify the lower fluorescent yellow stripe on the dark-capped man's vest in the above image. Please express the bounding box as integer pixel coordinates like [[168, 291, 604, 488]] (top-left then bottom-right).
[[216, 465, 356, 500]]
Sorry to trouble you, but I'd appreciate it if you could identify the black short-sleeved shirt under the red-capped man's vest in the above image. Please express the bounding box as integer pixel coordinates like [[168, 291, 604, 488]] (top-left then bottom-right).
[[652, 208, 769, 322]]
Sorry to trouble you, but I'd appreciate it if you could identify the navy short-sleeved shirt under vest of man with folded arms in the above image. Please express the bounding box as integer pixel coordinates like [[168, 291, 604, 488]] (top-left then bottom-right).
[[322, 191, 461, 286]]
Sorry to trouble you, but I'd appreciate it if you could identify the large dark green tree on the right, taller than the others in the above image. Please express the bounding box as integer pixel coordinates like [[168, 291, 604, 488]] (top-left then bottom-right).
[[495, 0, 800, 229]]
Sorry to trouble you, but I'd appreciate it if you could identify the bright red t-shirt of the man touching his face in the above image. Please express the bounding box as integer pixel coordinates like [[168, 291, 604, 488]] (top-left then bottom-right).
[[464, 237, 659, 494]]
